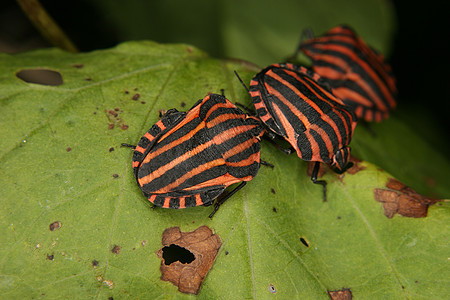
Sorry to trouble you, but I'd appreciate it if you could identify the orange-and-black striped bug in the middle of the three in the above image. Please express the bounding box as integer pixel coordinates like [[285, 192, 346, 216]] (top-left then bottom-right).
[[249, 64, 356, 200]]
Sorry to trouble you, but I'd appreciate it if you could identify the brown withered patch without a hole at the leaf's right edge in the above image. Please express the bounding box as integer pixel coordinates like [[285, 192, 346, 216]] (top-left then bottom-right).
[[374, 178, 439, 219]]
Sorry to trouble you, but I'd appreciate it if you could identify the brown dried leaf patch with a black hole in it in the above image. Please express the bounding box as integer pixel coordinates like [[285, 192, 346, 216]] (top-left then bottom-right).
[[156, 226, 222, 294]]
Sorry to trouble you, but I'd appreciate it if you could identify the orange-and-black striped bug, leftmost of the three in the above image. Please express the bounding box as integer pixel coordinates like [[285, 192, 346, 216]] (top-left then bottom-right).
[[123, 94, 265, 217]]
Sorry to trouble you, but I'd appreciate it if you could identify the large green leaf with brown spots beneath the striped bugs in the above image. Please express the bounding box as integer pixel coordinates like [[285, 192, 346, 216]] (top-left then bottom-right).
[[0, 42, 450, 299]]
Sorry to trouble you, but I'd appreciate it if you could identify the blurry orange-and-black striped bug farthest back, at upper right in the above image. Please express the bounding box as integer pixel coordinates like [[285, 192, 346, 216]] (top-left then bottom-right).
[[298, 25, 397, 122]]
